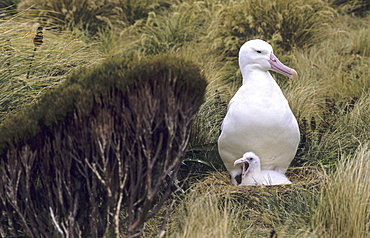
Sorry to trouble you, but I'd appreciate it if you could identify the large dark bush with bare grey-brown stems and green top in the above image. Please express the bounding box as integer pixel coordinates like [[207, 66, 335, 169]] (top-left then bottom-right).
[[0, 52, 206, 237]]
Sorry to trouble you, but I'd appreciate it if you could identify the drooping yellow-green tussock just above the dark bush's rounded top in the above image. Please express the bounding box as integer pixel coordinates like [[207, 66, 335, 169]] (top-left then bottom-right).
[[122, 2, 210, 54]]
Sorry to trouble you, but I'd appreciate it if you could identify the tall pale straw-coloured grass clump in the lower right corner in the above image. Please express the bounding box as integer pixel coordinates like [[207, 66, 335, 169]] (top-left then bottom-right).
[[313, 143, 370, 237]]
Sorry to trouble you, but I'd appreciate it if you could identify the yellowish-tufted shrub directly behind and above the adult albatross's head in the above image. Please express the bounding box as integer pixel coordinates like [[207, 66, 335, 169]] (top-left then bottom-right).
[[210, 0, 335, 57]]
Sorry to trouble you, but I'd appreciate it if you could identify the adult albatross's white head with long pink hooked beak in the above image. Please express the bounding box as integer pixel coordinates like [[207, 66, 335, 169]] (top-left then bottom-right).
[[239, 39, 298, 79]]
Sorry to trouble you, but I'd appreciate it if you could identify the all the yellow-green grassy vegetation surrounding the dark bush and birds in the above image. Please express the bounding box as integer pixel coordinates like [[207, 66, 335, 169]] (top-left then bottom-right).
[[0, 0, 370, 237]]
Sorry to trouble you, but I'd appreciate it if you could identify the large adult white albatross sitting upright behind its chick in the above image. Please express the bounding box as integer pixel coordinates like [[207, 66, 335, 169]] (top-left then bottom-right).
[[218, 40, 300, 185]]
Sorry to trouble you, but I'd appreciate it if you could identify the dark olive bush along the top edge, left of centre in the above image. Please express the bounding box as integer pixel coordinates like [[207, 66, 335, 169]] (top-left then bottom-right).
[[19, 0, 169, 35]]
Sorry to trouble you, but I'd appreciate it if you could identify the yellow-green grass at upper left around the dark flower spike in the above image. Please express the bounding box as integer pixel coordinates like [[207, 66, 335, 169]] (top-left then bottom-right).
[[0, 13, 102, 121]]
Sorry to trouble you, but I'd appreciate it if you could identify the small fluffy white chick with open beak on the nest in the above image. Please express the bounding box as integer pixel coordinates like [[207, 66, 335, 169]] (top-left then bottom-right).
[[234, 152, 292, 185]]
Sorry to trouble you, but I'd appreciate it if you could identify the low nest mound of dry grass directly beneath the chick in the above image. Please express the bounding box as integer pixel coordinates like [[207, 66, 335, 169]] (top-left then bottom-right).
[[192, 167, 324, 211]]
